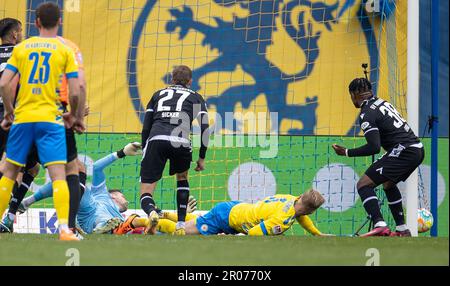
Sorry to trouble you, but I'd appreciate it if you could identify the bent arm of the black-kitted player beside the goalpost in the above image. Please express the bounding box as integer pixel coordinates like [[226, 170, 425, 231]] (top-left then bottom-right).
[[333, 112, 381, 157]]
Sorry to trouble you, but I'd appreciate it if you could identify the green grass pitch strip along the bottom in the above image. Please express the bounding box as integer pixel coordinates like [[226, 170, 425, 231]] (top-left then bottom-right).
[[0, 234, 449, 266]]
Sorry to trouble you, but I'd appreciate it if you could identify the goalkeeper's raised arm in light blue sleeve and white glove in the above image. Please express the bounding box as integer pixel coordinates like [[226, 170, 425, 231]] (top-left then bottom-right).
[[92, 142, 141, 191]]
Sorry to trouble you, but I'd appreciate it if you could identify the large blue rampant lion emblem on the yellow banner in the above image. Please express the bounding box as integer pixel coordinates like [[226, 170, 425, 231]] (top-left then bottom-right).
[[165, 0, 353, 135]]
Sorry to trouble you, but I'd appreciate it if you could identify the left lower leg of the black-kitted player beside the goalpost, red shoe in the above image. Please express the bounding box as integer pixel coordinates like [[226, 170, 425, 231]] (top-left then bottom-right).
[[356, 175, 390, 237]]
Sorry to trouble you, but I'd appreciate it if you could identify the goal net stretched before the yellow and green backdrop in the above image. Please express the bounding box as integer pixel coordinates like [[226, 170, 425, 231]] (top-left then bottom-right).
[[0, 0, 442, 235]]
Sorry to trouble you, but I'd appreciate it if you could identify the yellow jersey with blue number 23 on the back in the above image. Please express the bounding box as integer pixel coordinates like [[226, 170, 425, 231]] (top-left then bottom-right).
[[6, 37, 78, 124]]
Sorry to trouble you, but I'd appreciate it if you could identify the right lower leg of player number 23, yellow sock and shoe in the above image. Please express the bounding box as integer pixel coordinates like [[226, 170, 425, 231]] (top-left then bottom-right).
[[47, 164, 79, 241]]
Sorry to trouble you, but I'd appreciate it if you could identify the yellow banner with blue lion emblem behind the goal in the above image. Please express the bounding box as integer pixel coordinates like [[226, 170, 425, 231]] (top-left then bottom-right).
[[0, 0, 406, 135]]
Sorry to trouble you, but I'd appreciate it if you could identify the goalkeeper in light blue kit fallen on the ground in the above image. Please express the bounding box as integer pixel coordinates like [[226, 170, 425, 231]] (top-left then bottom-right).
[[19, 142, 153, 234]]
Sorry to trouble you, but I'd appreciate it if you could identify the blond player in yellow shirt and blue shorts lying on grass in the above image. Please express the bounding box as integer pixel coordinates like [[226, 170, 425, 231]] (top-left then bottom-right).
[[150, 190, 329, 236]]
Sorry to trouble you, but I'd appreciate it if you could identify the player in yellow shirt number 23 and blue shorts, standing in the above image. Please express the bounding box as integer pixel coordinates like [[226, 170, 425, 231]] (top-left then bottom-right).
[[0, 2, 84, 240]]
